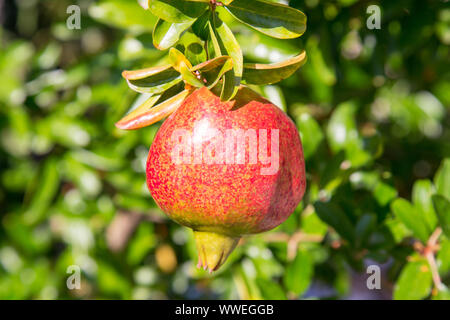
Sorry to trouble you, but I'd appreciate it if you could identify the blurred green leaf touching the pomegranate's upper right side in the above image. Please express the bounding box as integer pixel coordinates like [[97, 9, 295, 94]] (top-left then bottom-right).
[[295, 113, 323, 159]]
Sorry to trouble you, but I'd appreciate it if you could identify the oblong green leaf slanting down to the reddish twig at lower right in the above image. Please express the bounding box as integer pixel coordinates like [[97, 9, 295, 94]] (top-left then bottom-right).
[[391, 198, 431, 243]]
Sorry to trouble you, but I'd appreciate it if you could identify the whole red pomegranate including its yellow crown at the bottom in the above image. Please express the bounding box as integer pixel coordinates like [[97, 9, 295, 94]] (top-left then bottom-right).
[[146, 86, 306, 272]]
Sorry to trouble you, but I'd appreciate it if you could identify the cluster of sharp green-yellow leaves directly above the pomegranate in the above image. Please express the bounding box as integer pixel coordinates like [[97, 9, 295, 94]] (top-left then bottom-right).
[[116, 0, 306, 130]]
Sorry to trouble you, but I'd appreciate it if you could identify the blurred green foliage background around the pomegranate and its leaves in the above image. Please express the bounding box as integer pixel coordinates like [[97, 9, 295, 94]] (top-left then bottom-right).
[[0, 0, 450, 299]]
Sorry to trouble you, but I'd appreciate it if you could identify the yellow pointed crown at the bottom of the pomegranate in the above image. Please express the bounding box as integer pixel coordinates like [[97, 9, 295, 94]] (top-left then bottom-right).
[[194, 231, 240, 273]]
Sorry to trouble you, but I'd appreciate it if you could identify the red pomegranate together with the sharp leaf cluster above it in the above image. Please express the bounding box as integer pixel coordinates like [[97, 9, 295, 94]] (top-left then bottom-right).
[[116, 0, 306, 272]]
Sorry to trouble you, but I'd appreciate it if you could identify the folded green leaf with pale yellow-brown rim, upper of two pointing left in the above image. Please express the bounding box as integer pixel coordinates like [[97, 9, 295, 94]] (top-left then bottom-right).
[[122, 65, 182, 94]]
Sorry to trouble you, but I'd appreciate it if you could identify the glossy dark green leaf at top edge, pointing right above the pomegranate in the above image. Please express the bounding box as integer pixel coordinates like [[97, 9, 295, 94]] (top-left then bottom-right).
[[226, 0, 306, 39]]
